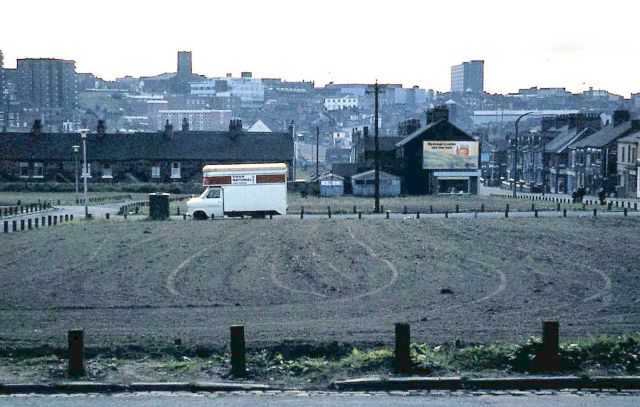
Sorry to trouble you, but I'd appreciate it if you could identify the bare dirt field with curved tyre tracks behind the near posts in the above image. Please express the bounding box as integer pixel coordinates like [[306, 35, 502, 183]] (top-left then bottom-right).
[[0, 218, 640, 348]]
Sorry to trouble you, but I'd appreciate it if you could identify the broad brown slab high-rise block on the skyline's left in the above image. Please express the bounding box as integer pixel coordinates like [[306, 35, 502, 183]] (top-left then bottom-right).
[[16, 58, 78, 110]]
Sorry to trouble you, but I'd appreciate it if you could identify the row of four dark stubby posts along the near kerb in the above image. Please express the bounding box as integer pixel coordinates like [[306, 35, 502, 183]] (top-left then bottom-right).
[[67, 321, 560, 378]]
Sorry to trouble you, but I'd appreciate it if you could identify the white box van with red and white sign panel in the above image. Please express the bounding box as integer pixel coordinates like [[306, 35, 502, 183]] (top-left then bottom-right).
[[187, 163, 287, 219]]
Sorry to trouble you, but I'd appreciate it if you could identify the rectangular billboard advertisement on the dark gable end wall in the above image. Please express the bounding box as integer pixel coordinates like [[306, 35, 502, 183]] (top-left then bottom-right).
[[422, 141, 478, 170]]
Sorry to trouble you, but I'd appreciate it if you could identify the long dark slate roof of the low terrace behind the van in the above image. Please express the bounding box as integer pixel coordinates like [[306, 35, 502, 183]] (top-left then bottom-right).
[[0, 131, 293, 163]]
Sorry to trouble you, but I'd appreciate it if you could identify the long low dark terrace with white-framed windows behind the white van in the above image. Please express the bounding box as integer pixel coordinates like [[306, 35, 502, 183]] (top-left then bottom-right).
[[0, 120, 293, 182]]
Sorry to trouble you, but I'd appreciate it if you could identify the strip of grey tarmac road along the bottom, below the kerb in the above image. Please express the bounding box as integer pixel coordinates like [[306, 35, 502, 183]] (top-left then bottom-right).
[[0, 391, 640, 407]]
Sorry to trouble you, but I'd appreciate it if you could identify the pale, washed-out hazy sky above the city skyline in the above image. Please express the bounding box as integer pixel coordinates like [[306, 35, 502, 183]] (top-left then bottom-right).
[[0, 0, 640, 97]]
